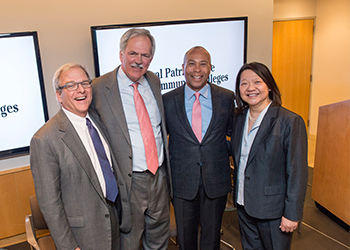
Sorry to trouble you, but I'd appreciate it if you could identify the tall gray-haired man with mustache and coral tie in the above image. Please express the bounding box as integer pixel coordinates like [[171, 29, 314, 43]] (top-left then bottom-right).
[[91, 29, 172, 250]]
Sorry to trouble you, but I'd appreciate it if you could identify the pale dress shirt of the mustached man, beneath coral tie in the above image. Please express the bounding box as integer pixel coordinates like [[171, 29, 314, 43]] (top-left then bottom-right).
[[116, 68, 164, 171]]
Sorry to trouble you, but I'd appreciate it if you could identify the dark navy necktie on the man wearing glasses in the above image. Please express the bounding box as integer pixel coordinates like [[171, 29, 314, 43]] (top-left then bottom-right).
[[86, 118, 118, 202]]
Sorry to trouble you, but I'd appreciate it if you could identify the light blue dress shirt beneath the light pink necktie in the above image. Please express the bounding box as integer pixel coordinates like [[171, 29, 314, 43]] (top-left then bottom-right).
[[185, 84, 213, 139]]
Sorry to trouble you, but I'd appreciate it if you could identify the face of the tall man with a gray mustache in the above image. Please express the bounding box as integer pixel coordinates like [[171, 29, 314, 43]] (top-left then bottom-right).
[[119, 36, 153, 82]]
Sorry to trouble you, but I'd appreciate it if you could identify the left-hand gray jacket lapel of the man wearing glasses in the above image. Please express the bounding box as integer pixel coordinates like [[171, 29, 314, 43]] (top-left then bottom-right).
[[58, 109, 105, 203]]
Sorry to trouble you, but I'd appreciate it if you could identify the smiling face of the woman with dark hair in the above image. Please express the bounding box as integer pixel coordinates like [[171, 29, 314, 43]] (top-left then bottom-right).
[[239, 69, 270, 111]]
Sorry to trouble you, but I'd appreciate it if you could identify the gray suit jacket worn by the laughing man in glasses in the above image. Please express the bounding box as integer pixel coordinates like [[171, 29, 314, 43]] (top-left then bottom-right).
[[30, 109, 123, 250]]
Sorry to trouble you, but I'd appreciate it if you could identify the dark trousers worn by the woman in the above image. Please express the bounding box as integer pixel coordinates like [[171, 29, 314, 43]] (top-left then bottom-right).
[[237, 205, 293, 250]]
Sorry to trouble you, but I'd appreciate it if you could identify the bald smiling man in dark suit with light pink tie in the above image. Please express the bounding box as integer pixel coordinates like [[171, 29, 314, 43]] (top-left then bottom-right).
[[163, 47, 234, 250]]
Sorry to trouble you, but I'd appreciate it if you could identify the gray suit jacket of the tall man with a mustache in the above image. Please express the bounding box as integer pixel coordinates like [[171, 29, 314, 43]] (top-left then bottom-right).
[[90, 67, 172, 233]]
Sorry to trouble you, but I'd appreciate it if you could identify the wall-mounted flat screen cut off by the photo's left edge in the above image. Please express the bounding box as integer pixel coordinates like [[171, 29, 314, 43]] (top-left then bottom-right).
[[0, 31, 48, 159]]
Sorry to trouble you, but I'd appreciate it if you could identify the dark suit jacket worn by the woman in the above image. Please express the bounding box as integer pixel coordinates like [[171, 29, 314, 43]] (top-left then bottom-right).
[[231, 106, 308, 221]]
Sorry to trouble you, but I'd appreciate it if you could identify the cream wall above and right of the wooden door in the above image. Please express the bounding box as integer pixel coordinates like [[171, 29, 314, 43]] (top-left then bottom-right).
[[273, 0, 350, 137]]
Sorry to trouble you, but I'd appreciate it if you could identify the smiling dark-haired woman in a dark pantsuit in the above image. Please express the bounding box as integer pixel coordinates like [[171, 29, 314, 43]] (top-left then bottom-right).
[[231, 62, 308, 250]]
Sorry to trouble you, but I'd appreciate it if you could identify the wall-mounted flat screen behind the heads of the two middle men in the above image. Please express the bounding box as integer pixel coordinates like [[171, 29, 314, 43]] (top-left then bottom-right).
[[91, 17, 248, 94]]
